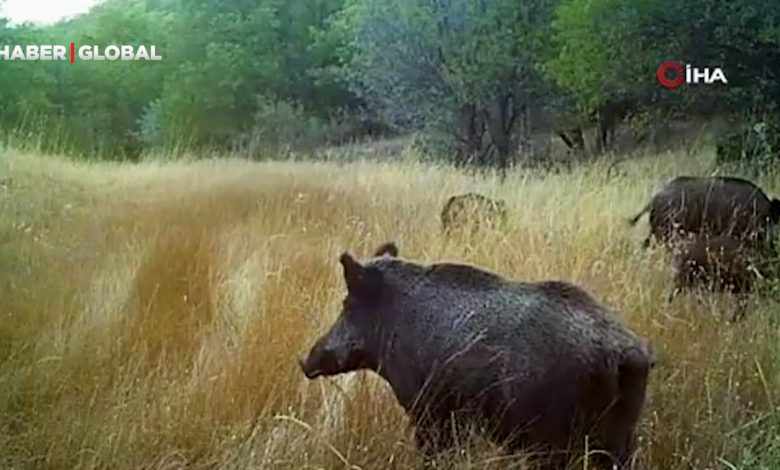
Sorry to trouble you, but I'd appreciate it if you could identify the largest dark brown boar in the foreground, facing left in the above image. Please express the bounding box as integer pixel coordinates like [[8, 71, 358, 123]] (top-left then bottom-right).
[[301, 244, 653, 469]]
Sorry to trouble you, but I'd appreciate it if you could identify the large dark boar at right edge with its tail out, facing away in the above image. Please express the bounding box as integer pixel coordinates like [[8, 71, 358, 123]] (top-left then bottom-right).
[[630, 176, 780, 247]]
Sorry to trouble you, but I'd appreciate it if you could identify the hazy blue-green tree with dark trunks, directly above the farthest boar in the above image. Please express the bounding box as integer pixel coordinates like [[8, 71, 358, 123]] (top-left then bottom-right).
[[334, 0, 551, 169]]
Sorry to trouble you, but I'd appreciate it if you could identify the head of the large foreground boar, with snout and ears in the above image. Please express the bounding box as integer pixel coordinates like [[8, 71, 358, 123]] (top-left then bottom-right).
[[300, 243, 398, 379]]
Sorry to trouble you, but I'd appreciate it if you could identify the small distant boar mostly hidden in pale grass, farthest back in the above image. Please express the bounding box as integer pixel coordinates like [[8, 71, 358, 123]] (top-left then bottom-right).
[[440, 193, 507, 235]]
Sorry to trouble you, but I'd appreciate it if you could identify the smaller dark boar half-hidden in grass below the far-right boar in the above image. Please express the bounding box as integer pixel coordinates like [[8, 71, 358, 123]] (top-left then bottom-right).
[[670, 236, 769, 320]]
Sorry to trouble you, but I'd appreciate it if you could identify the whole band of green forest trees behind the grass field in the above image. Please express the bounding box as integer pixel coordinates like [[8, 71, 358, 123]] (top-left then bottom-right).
[[0, 0, 780, 167]]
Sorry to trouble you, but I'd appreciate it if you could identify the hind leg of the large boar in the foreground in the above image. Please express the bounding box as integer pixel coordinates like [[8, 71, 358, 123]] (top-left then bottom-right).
[[601, 357, 650, 468]]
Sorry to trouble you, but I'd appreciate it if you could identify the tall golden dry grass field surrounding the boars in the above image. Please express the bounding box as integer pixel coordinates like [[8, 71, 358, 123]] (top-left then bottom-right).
[[0, 146, 780, 469]]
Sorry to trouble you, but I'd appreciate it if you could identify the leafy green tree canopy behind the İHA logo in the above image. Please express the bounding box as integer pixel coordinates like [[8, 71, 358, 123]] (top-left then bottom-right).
[[545, 0, 780, 121]]
